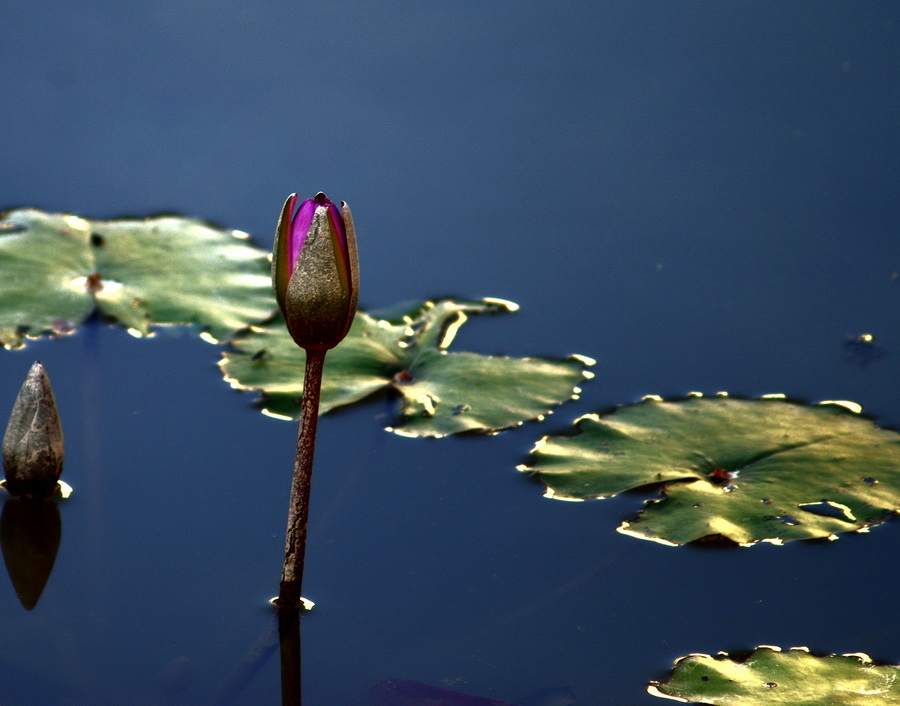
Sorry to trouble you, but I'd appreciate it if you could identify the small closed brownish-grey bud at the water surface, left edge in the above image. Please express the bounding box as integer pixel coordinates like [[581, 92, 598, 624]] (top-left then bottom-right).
[[3, 361, 63, 498]]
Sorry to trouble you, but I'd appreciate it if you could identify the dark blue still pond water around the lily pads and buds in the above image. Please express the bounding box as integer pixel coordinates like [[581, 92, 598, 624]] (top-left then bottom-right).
[[0, 0, 900, 706]]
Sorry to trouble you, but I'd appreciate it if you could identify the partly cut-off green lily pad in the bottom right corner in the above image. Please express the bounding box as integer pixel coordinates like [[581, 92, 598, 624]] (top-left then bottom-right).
[[647, 646, 900, 706]]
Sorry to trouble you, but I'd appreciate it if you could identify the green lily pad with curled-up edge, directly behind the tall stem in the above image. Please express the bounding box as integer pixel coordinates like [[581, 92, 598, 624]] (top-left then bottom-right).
[[219, 299, 593, 437]]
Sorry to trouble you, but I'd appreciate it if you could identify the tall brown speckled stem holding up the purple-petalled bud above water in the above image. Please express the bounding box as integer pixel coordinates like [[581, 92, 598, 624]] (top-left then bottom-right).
[[278, 350, 326, 612]]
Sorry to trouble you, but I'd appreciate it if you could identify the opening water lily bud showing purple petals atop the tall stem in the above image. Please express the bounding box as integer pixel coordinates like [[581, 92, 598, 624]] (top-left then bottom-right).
[[272, 193, 359, 350]]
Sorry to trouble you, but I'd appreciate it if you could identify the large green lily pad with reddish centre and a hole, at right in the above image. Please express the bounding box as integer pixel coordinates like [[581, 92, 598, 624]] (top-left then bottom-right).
[[519, 395, 900, 546]]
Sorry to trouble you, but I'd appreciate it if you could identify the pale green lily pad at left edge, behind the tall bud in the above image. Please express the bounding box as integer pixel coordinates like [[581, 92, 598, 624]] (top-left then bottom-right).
[[0, 209, 275, 348]]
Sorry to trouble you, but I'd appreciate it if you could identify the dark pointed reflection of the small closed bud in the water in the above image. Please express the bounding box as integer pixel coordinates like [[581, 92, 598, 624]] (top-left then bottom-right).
[[0, 498, 62, 610]]
